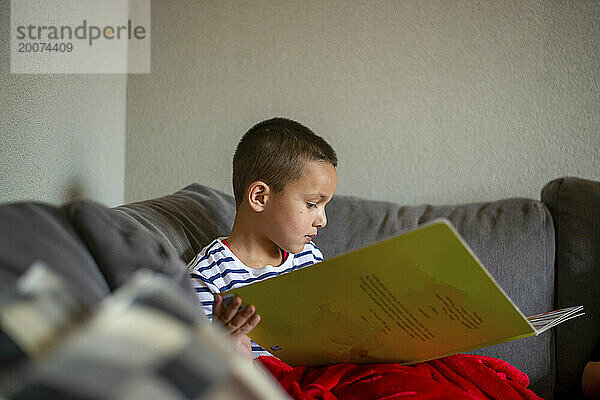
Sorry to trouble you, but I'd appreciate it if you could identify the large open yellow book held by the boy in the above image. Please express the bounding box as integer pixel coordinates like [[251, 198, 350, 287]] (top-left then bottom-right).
[[225, 219, 583, 365]]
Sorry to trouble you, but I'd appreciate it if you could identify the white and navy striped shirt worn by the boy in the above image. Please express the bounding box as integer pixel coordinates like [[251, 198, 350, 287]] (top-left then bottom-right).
[[188, 238, 323, 358]]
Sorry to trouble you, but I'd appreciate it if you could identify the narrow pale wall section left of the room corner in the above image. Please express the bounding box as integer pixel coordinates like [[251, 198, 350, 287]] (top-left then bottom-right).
[[0, 0, 127, 205]]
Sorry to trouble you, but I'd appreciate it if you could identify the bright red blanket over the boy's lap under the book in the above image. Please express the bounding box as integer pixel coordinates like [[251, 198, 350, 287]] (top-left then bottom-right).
[[259, 354, 540, 400]]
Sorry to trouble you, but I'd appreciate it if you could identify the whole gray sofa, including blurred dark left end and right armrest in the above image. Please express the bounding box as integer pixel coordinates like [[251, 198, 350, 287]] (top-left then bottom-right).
[[0, 178, 600, 399]]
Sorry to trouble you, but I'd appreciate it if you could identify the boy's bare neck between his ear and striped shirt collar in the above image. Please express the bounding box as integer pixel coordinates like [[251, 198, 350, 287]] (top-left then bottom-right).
[[227, 215, 284, 268]]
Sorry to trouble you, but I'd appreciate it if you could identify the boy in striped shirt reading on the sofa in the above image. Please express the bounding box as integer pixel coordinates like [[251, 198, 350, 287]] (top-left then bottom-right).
[[188, 118, 337, 357]]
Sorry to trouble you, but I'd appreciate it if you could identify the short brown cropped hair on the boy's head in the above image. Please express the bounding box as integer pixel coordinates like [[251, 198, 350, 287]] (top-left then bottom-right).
[[233, 118, 337, 206]]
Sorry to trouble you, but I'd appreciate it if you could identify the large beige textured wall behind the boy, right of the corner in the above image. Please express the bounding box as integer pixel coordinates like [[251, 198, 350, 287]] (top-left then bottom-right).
[[126, 0, 600, 204]]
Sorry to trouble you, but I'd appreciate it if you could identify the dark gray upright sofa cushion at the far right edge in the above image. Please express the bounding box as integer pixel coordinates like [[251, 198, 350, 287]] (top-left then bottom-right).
[[542, 178, 600, 398]]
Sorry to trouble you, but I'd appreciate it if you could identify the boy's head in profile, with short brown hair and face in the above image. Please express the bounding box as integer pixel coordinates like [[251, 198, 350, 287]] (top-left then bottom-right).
[[232, 118, 337, 253]]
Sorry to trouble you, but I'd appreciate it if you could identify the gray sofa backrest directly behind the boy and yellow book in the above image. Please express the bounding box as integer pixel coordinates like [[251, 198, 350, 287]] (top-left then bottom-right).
[[117, 184, 554, 397]]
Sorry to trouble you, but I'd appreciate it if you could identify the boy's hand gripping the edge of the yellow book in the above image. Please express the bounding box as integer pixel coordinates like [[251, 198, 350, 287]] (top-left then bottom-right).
[[213, 294, 260, 335]]
